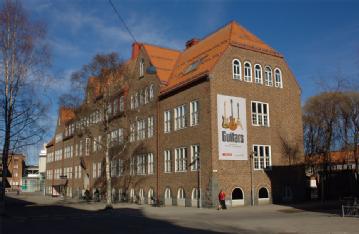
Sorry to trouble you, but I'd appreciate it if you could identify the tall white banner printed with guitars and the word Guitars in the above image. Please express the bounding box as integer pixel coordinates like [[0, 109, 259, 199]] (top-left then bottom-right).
[[217, 94, 248, 160]]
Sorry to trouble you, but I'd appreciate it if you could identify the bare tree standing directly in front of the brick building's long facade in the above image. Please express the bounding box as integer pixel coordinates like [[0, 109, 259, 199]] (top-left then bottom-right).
[[63, 53, 149, 207]]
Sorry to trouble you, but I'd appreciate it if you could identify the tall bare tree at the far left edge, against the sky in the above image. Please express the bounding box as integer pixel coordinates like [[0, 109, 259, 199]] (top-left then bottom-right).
[[0, 0, 49, 208]]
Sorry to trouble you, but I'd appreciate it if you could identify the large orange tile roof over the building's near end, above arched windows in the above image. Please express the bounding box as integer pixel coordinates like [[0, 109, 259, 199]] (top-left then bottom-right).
[[134, 21, 282, 93]]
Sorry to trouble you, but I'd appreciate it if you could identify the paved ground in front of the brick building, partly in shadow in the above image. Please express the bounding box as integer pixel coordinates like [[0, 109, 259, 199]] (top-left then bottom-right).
[[0, 192, 359, 234]]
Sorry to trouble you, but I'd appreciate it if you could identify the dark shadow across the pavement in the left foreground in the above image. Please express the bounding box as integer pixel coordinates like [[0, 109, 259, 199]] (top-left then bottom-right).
[[0, 197, 233, 234]]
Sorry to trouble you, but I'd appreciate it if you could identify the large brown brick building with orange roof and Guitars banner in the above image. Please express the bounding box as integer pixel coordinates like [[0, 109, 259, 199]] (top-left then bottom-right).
[[46, 22, 304, 206]]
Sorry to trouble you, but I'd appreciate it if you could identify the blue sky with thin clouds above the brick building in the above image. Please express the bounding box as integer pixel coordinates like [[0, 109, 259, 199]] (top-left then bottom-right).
[[23, 0, 359, 163]]
